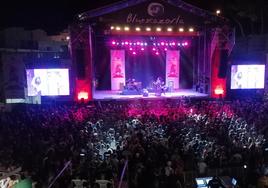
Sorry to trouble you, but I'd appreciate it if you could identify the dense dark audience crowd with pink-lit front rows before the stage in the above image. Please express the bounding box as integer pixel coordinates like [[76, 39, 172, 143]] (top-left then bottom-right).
[[0, 98, 268, 188]]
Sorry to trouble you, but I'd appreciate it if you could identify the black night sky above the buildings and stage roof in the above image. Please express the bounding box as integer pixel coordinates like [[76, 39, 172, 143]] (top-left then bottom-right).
[[0, 0, 265, 34]]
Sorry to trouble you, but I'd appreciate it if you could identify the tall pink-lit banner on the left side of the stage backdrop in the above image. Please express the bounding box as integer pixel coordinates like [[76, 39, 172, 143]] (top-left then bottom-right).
[[111, 50, 126, 90]]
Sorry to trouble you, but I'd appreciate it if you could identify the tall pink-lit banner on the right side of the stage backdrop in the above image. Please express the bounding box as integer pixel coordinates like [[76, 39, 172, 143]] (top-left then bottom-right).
[[166, 50, 180, 91]]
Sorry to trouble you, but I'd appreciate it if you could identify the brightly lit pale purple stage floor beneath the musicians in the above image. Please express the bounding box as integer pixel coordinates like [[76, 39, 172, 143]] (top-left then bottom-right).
[[93, 89, 208, 100]]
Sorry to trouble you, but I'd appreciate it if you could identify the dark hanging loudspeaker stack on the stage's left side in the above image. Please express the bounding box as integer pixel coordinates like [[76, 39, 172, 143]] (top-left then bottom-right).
[[75, 49, 86, 79]]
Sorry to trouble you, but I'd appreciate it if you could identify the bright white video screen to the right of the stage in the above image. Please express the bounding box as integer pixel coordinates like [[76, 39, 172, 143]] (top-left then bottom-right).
[[231, 65, 265, 89]]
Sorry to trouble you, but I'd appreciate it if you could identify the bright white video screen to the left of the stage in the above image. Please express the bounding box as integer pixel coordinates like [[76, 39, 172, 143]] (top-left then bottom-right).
[[26, 69, 70, 96]]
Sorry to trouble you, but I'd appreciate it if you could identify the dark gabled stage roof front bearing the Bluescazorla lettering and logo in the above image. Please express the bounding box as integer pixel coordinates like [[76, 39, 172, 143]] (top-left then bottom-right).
[[75, 0, 228, 27]]
